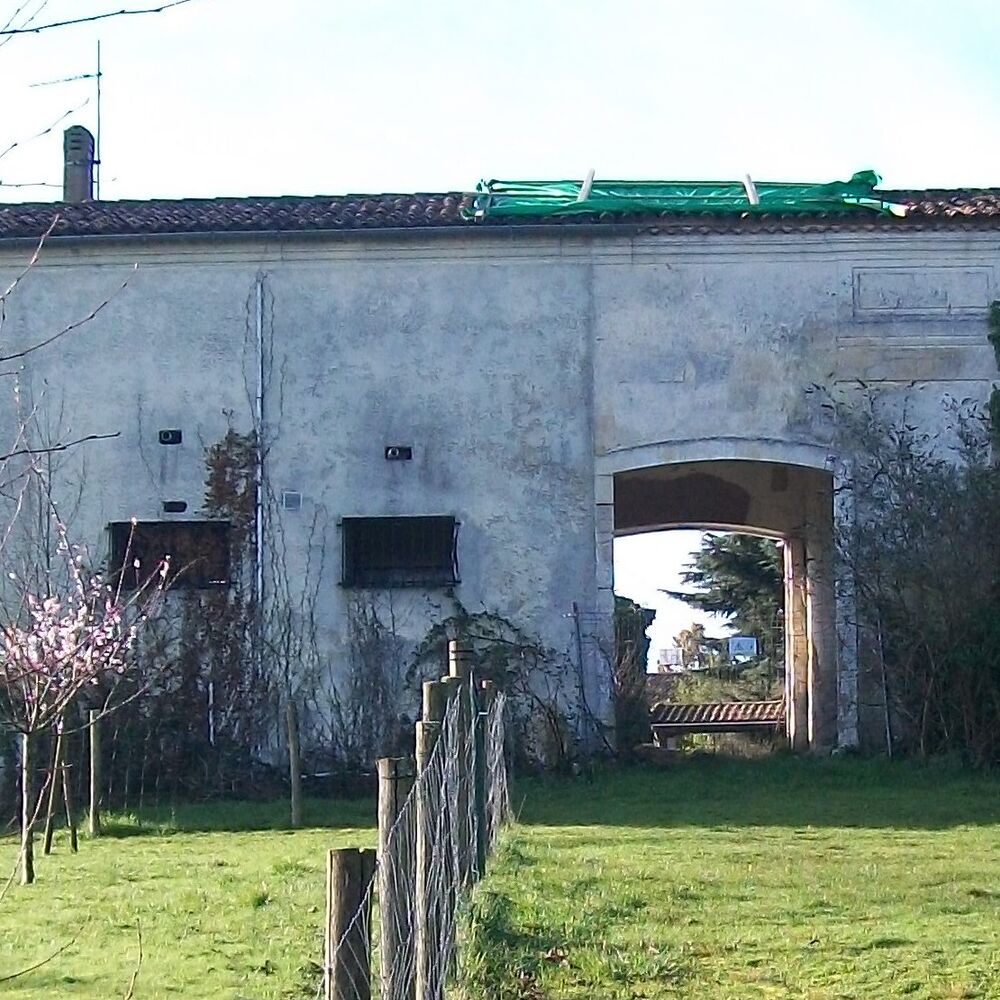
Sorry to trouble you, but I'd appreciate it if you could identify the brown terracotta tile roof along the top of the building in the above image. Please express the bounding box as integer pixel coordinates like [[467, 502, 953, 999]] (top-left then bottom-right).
[[0, 188, 1000, 240]]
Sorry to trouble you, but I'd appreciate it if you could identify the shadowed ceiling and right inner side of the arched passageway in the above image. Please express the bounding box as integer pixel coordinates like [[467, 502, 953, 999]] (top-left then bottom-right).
[[613, 459, 837, 751]]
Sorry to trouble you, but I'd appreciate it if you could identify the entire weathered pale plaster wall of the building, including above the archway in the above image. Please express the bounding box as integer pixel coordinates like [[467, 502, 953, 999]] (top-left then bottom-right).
[[2, 223, 1000, 748]]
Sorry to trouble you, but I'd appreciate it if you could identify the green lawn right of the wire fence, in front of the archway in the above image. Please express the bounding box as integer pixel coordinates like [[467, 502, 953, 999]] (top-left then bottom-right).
[[465, 756, 1000, 1000]]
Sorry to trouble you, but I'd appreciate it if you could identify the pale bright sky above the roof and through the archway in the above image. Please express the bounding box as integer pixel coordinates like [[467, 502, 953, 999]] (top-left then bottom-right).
[[0, 0, 1000, 664]]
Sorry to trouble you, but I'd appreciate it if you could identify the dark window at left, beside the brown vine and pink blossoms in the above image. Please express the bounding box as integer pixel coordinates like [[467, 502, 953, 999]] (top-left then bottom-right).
[[108, 521, 230, 589]]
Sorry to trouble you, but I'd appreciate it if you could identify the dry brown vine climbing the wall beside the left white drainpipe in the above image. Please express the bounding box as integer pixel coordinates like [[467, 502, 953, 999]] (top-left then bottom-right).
[[95, 428, 283, 808]]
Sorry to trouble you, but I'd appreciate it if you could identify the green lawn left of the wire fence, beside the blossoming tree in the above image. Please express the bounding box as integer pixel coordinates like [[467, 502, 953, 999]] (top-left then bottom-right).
[[0, 801, 375, 1000]]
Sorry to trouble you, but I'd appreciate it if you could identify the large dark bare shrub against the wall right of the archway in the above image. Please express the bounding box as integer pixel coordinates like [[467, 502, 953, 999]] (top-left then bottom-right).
[[825, 303, 1000, 767]]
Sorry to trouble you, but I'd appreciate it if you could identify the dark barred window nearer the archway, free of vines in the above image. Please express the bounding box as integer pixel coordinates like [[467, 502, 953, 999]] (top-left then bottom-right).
[[341, 517, 458, 587]]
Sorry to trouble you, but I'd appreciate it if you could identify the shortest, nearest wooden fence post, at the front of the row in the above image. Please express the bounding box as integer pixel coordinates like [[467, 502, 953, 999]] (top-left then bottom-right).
[[326, 847, 375, 1000]]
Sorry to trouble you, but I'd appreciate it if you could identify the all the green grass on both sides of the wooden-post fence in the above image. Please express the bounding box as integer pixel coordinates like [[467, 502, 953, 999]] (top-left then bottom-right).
[[0, 755, 1000, 1000]]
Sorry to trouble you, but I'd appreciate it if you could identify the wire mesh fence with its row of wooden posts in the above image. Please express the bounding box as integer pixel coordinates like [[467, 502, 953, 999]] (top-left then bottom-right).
[[320, 643, 509, 1000]]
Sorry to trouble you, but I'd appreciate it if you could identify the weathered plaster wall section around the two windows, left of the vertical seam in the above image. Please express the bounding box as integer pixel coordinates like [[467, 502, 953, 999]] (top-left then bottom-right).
[[0, 238, 594, 724]]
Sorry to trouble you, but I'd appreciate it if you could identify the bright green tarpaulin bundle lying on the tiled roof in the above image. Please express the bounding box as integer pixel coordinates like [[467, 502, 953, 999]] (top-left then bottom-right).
[[468, 170, 906, 219]]
